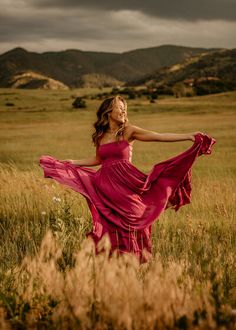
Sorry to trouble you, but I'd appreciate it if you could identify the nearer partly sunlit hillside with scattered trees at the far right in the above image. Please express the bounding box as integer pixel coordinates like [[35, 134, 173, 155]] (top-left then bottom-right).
[[132, 49, 236, 91]]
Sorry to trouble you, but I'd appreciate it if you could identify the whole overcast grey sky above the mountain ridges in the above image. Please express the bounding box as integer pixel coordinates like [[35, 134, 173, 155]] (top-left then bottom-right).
[[0, 0, 236, 53]]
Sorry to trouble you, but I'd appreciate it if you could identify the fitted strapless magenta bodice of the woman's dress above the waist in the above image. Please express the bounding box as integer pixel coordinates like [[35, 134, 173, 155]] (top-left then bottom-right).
[[98, 139, 133, 165]]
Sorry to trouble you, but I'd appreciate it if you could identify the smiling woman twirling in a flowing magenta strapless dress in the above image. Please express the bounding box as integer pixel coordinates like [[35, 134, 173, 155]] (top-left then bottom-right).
[[40, 95, 216, 263]]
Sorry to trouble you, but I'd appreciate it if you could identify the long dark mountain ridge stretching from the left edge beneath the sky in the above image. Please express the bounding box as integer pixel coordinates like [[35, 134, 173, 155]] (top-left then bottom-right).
[[0, 45, 219, 88]]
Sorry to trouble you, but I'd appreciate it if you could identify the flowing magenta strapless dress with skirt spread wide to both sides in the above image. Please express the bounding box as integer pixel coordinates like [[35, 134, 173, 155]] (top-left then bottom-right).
[[39, 133, 216, 262]]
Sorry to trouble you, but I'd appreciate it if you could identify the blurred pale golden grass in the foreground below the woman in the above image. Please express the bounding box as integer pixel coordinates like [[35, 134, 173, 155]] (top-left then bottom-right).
[[2, 232, 224, 329]]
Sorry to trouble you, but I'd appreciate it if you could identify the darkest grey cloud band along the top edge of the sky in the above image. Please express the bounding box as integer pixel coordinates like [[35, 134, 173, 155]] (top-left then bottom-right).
[[31, 0, 236, 21]]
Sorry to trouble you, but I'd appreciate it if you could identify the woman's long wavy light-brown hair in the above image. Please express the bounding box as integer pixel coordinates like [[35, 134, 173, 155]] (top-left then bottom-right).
[[92, 95, 128, 146]]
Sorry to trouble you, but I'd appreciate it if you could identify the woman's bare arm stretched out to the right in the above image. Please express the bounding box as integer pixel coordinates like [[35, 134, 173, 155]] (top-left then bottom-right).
[[131, 126, 203, 142]]
